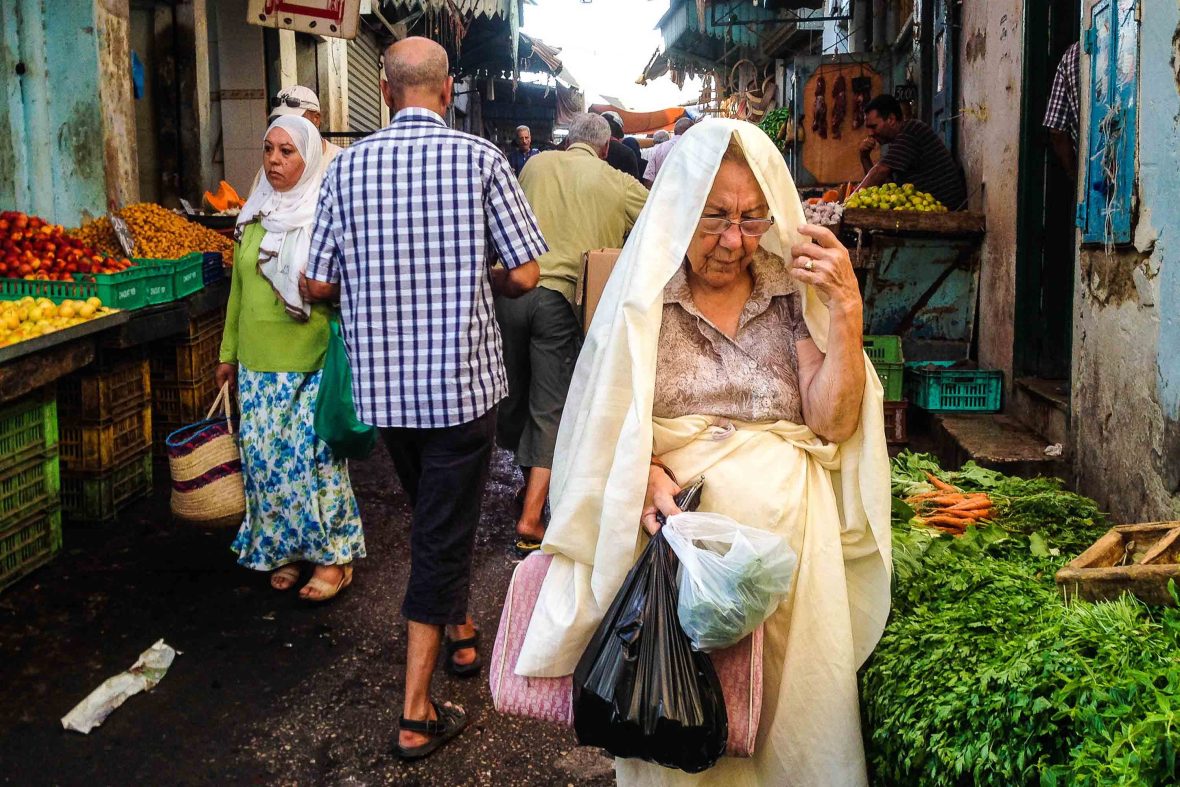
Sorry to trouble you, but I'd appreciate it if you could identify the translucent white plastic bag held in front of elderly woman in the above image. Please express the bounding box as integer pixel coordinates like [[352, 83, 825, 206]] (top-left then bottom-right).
[[663, 513, 799, 650]]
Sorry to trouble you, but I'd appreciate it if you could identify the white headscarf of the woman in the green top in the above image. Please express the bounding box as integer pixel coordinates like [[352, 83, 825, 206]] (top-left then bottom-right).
[[237, 114, 323, 321]]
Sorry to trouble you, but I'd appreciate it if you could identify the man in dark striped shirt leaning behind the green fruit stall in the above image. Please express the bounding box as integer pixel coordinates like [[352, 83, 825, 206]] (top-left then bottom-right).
[[858, 93, 966, 210]]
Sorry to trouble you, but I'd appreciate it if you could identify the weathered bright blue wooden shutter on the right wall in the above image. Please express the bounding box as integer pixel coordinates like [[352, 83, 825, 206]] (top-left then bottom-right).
[[1081, 0, 1139, 243]]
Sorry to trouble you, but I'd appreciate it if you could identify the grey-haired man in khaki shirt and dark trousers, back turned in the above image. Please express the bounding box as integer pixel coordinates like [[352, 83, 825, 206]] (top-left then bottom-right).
[[496, 113, 648, 553]]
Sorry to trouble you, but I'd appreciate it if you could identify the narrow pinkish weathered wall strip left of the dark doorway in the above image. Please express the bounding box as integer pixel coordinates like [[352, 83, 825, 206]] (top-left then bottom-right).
[[957, 0, 1023, 387]]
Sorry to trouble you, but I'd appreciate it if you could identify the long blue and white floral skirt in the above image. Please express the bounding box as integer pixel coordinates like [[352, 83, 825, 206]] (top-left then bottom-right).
[[232, 365, 365, 571]]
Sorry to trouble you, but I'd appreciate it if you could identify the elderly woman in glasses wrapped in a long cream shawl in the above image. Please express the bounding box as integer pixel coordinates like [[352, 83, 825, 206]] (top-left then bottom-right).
[[516, 120, 890, 787]]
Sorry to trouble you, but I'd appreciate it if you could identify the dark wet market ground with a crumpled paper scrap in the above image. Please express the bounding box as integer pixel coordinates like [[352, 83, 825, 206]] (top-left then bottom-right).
[[0, 447, 614, 786]]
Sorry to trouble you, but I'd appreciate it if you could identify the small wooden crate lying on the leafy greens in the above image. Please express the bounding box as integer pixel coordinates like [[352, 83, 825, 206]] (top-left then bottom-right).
[[1056, 522, 1180, 606]]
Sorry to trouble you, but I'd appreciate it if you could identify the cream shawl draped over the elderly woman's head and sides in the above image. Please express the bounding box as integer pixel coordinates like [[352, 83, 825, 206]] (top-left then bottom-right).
[[516, 119, 891, 676]]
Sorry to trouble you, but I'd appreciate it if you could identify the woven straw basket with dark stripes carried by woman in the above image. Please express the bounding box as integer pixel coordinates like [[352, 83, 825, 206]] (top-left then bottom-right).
[[166, 383, 245, 527]]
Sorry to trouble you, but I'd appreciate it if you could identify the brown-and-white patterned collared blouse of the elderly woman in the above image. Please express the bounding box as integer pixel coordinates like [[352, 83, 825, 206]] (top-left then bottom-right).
[[653, 249, 811, 424]]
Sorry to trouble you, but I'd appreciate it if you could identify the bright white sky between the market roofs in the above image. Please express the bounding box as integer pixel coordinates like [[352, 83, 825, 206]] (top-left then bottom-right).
[[524, 0, 701, 111]]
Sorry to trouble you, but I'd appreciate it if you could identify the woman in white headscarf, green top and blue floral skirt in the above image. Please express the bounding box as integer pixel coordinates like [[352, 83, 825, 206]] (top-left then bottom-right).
[[217, 116, 365, 601]]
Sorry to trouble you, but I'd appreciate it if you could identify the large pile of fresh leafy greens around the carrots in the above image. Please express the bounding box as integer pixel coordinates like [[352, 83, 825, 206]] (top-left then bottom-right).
[[861, 452, 1180, 786]]
